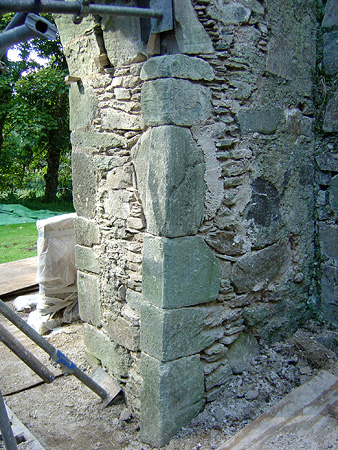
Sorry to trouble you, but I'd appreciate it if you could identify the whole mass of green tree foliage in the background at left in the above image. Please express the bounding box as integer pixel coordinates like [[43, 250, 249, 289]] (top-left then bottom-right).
[[0, 14, 71, 201]]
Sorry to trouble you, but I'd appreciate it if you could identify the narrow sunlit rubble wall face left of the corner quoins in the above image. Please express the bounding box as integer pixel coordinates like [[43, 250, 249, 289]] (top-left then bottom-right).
[[56, 7, 146, 414]]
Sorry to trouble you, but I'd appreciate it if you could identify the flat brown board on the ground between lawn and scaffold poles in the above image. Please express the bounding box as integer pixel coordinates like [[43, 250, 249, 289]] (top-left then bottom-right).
[[0, 256, 38, 296]]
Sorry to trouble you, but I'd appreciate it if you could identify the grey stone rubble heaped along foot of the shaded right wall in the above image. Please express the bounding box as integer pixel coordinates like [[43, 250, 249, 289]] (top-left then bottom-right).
[[168, 323, 338, 450]]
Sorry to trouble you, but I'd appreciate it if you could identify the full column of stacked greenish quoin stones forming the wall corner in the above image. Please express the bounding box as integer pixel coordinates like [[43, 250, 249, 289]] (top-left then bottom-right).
[[137, 51, 219, 445]]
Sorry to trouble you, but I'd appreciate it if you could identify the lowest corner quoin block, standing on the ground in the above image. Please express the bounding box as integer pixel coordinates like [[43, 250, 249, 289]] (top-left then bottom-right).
[[140, 353, 204, 446]]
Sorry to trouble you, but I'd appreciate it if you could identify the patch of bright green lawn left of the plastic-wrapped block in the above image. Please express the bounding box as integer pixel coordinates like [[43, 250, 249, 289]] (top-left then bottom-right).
[[0, 223, 38, 264]]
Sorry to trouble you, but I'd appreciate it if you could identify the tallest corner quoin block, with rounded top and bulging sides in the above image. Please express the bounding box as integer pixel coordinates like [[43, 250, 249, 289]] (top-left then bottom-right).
[[133, 126, 206, 237]]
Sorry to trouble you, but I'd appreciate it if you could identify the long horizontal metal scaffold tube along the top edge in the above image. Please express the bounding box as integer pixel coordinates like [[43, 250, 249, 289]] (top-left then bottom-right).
[[0, 0, 163, 18]]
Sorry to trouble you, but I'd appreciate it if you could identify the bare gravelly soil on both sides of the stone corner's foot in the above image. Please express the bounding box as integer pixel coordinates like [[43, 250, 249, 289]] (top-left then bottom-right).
[[0, 296, 338, 450]]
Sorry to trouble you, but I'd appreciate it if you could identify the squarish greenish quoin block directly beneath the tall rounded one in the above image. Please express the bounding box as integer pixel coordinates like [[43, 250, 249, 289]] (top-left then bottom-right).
[[142, 235, 220, 309]]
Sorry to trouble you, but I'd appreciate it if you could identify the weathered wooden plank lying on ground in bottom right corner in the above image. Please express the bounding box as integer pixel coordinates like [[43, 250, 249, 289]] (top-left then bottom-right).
[[217, 370, 338, 450]]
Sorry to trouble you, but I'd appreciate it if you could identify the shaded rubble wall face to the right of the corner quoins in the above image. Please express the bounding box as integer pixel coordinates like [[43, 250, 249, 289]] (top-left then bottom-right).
[[193, 0, 318, 348]]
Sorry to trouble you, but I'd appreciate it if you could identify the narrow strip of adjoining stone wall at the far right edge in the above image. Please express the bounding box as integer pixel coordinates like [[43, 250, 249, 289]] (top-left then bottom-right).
[[315, 0, 338, 324]]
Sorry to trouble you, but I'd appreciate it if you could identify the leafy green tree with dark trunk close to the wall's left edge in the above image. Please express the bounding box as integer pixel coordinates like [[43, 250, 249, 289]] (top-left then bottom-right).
[[7, 65, 70, 201]]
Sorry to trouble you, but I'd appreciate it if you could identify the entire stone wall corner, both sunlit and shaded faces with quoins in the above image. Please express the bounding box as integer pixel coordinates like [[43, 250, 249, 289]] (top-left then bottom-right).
[[57, 0, 332, 446]]
